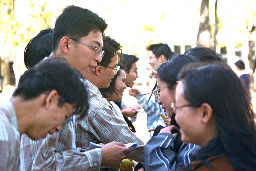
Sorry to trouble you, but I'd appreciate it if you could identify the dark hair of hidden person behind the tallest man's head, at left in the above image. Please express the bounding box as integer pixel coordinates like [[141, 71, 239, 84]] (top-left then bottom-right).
[[24, 28, 53, 69]]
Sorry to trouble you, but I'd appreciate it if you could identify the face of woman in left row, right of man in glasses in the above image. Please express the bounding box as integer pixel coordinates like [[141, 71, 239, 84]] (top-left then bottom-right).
[[111, 70, 127, 101]]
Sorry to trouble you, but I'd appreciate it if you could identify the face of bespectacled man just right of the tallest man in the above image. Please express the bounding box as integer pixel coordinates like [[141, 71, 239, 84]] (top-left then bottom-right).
[[98, 55, 118, 88]]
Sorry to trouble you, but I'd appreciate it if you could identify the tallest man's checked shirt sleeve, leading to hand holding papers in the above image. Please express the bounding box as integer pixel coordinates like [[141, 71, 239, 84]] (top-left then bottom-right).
[[32, 119, 101, 170]]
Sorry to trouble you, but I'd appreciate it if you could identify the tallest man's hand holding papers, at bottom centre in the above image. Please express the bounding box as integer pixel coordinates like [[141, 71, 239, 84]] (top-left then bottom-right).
[[101, 142, 131, 168]]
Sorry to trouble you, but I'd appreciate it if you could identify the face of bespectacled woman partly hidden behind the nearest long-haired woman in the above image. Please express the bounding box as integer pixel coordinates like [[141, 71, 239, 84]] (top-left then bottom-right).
[[157, 78, 175, 118]]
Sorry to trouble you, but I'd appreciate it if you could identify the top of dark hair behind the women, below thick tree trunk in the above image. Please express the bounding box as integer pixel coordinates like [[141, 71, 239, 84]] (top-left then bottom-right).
[[184, 47, 223, 62]]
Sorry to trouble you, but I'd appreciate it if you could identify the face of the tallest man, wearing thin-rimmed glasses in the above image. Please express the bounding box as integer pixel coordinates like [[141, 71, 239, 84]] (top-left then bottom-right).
[[67, 31, 103, 78]]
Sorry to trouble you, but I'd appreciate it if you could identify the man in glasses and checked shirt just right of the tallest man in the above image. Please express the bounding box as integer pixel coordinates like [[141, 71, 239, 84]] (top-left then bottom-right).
[[75, 37, 144, 170]]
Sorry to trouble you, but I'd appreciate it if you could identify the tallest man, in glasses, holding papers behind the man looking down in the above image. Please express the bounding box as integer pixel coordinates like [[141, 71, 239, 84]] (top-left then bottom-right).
[[22, 6, 130, 170]]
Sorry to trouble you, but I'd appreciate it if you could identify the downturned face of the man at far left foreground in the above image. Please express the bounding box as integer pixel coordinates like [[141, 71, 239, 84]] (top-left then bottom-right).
[[25, 92, 75, 140]]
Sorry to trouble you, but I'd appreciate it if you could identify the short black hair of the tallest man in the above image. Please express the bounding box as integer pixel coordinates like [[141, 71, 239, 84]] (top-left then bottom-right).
[[53, 5, 107, 50]]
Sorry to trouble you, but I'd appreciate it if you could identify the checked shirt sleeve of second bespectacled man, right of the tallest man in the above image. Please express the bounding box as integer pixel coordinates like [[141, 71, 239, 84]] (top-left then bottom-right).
[[76, 103, 144, 162]]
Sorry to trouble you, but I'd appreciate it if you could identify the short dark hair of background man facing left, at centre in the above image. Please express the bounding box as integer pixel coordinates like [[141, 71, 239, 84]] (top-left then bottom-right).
[[147, 43, 175, 60]]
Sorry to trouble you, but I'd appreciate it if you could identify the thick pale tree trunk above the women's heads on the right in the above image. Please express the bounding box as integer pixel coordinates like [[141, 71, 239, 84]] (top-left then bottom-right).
[[196, 0, 213, 48]]
